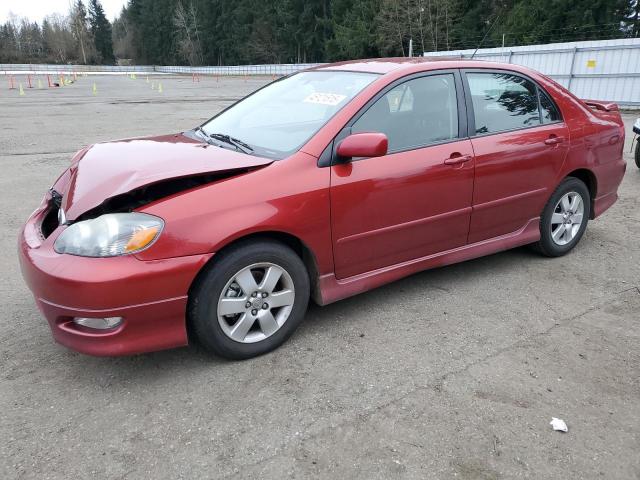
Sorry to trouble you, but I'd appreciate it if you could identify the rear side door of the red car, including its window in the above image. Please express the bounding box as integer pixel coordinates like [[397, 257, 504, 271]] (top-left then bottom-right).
[[463, 69, 569, 243]]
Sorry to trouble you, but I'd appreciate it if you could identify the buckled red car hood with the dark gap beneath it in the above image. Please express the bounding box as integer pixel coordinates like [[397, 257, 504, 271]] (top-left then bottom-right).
[[41, 134, 273, 238]]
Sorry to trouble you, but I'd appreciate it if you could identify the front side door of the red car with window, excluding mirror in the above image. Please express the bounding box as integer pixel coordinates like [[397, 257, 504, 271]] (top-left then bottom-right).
[[331, 70, 474, 279]]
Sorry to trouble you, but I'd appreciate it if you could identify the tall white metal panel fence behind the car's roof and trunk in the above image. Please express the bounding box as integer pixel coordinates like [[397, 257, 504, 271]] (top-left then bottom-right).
[[424, 38, 640, 106]]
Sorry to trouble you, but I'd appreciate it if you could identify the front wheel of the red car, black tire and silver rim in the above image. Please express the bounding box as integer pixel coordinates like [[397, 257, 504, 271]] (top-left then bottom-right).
[[187, 240, 310, 360]]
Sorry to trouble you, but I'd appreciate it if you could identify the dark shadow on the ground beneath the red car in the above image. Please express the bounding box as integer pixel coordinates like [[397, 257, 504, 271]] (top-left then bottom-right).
[[55, 242, 564, 383]]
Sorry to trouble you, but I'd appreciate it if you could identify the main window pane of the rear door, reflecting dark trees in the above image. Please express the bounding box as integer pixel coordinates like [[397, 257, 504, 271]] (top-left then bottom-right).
[[467, 73, 541, 134]]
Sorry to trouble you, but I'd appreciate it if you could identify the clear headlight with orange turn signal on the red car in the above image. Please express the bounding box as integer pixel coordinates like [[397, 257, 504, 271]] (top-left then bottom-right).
[[53, 213, 164, 257]]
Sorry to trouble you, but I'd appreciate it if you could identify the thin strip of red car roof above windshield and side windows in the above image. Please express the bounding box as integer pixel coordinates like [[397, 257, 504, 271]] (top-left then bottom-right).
[[309, 56, 529, 75]]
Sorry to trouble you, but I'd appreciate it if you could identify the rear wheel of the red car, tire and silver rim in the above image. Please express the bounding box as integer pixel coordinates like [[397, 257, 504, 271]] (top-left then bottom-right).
[[534, 177, 591, 257]]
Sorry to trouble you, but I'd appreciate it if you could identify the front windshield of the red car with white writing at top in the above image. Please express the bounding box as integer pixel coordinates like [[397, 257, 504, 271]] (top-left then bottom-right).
[[202, 72, 378, 159]]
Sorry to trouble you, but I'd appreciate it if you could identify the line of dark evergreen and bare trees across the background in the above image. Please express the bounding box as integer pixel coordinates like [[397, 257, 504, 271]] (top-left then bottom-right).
[[0, 0, 640, 65]]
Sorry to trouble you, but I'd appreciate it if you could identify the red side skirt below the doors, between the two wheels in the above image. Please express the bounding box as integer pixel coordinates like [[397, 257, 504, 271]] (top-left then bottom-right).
[[318, 217, 540, 305]]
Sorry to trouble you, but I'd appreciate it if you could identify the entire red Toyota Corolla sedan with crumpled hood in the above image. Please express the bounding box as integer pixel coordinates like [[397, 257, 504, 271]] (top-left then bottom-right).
[[19, 59, 626, 359]]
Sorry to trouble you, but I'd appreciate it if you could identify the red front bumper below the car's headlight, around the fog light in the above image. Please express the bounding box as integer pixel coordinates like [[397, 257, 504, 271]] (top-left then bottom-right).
[[18, 203, 212, 356]]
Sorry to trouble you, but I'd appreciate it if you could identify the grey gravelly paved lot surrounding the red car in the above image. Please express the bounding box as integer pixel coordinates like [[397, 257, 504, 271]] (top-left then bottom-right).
[[0, 76, 640, 479]]
